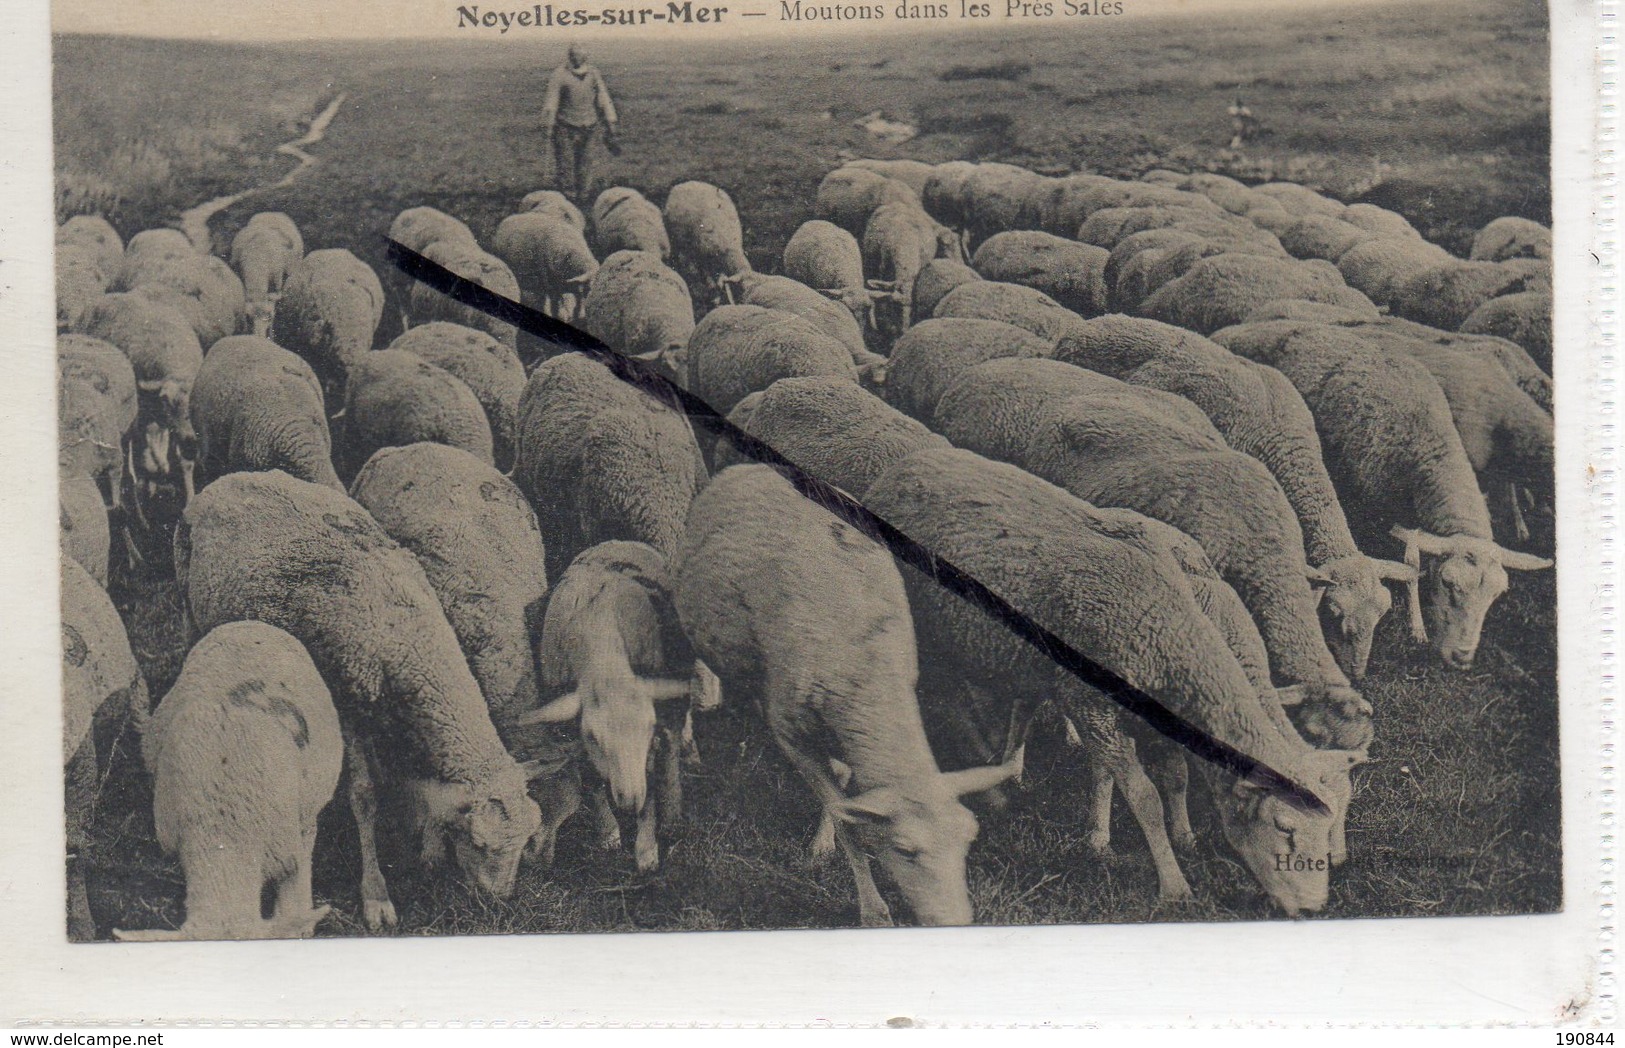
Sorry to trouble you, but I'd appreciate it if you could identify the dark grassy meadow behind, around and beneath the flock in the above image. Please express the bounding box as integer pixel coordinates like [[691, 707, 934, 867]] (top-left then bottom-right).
[[57, 0, 1560, 934]]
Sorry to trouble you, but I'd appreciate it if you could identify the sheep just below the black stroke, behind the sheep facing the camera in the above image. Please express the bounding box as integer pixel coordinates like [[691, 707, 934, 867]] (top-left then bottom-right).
[[514, 353, 705, 578]]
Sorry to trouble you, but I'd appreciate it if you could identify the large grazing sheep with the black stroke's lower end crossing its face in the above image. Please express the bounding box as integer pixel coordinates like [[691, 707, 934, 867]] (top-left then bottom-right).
[[865, 448, 1360, 915]]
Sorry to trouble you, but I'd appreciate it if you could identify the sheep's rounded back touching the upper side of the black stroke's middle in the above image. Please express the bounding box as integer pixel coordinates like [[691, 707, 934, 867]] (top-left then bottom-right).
[[686, 305, 858, 414]]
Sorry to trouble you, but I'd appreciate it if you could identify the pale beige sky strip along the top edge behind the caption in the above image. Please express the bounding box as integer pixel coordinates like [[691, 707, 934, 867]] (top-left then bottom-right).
[[52, 0, 1417, 42]]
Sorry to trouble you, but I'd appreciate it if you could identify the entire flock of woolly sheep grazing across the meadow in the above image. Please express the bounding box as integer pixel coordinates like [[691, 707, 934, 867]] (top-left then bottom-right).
[[57, 153, 1554, 939]]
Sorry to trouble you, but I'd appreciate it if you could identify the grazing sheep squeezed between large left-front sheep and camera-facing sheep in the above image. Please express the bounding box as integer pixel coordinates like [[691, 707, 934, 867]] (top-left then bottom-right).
[[351, 444, 548, 734]]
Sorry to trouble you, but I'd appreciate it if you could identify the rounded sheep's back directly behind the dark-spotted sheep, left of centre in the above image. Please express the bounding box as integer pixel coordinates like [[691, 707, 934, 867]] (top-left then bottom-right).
[[338, 349, 494, 478]]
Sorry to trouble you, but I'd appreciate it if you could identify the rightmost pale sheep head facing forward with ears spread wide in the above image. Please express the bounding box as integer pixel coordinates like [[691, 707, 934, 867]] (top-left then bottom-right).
[[1393, 526, 1552, 669]]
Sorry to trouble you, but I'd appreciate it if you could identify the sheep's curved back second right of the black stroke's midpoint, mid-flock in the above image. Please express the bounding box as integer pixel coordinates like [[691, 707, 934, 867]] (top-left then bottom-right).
[[886, 317, 1055, 426]]
